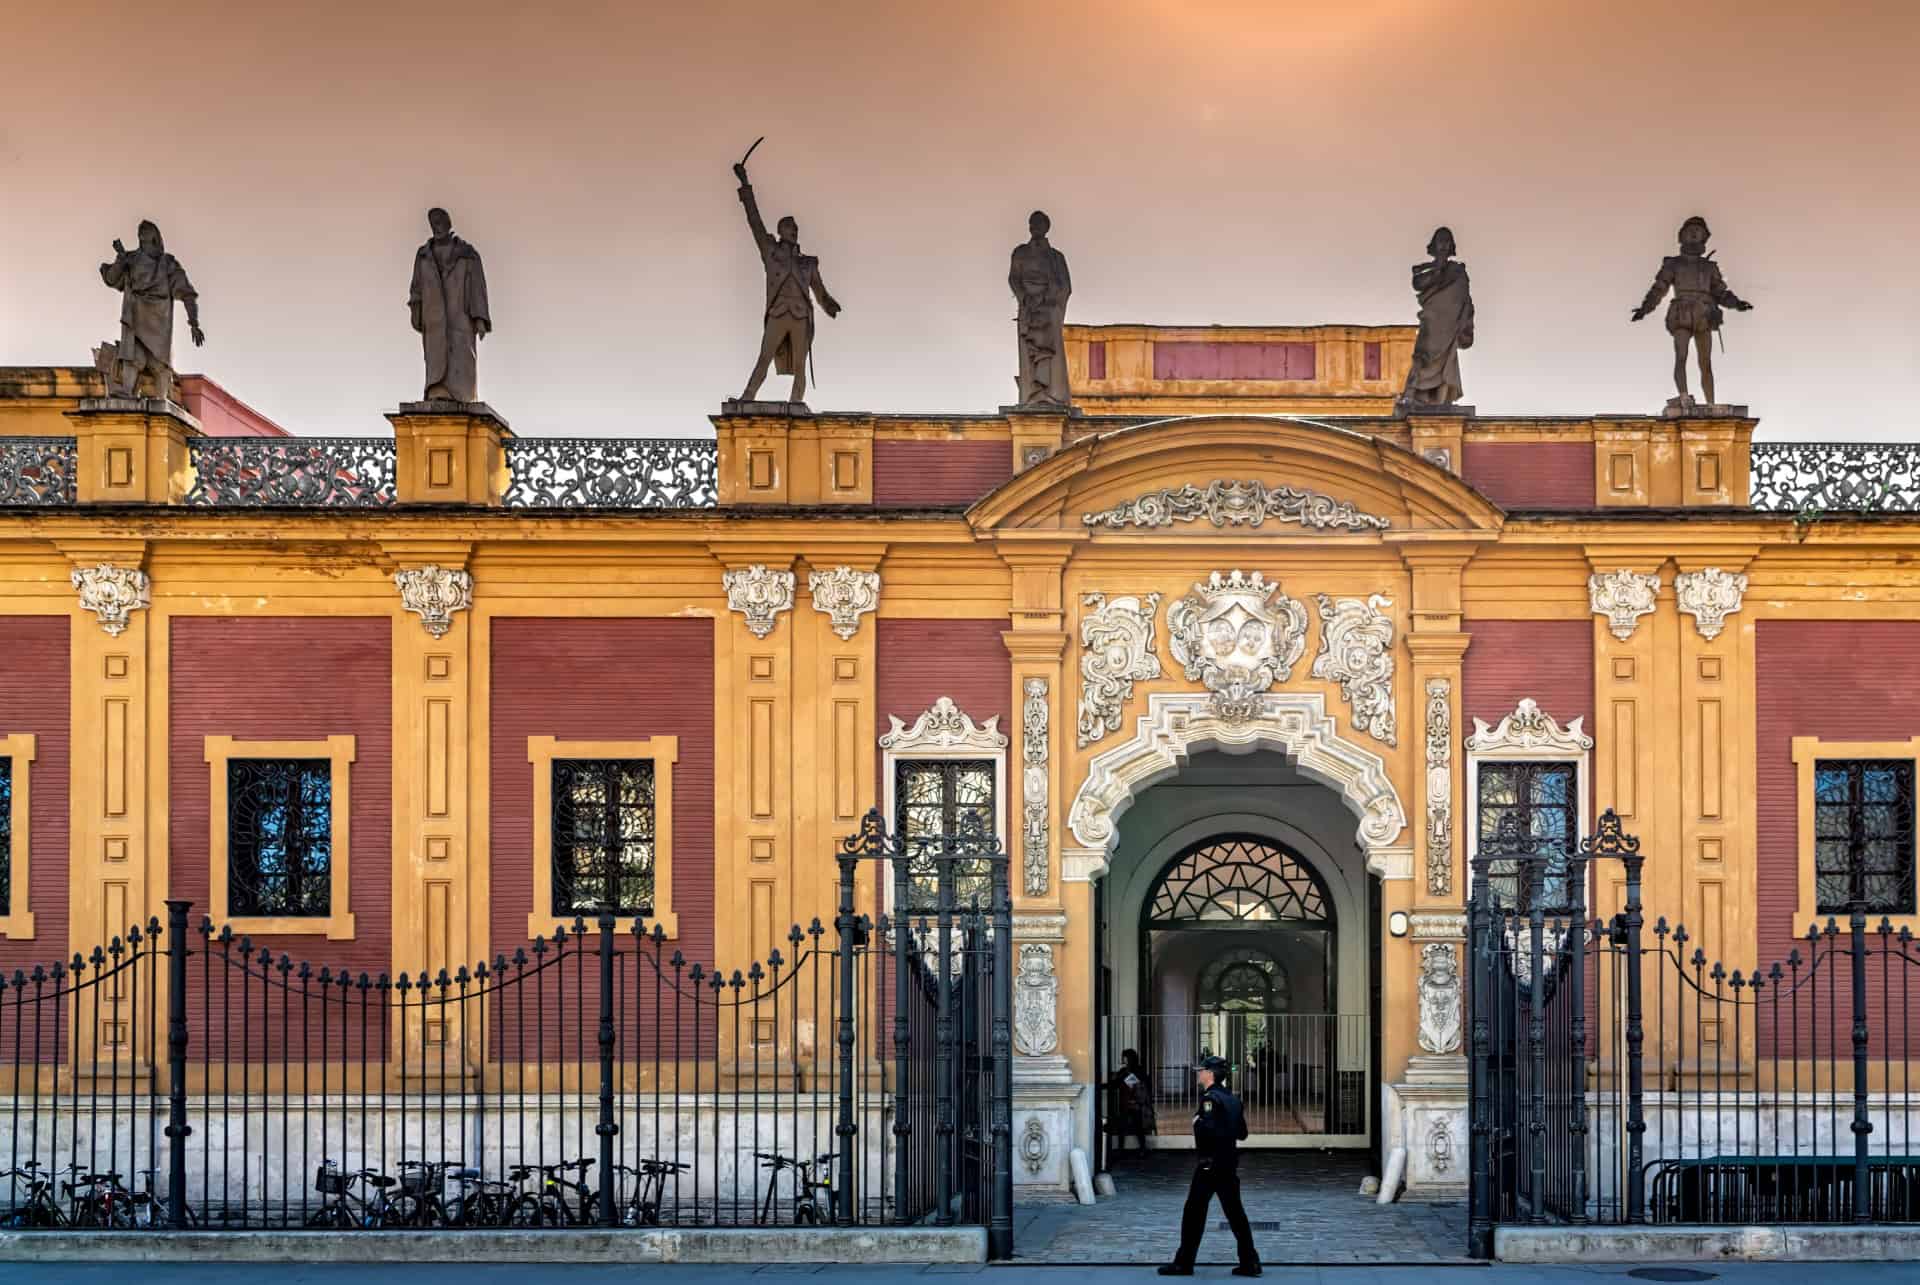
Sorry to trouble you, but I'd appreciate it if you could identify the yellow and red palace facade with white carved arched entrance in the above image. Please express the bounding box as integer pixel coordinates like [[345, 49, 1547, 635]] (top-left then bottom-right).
[[0, 318, 1920, 1193]]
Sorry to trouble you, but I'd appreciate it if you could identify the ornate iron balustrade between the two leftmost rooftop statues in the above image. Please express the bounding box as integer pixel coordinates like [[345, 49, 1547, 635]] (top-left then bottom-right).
[[186, 438, 397, 509]]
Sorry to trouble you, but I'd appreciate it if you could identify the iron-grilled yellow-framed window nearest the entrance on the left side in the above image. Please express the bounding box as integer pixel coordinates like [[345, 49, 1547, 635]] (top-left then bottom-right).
[[553, 759, 653, 916]]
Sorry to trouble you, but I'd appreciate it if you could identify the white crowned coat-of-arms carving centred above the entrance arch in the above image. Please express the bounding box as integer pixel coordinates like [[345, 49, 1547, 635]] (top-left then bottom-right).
[[1167, 570, 1308, 722]]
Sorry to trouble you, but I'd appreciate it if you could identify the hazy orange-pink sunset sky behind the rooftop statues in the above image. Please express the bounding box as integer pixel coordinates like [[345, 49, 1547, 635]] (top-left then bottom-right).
[[0, 0, 1920, 438]]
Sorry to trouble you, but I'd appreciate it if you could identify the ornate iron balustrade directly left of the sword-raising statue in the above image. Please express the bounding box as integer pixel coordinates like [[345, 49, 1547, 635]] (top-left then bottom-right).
[[507, 438, 720, 509]]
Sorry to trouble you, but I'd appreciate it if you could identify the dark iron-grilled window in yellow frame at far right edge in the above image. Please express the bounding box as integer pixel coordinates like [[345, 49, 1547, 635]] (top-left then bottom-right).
[[1812, 759, 1914, 914]]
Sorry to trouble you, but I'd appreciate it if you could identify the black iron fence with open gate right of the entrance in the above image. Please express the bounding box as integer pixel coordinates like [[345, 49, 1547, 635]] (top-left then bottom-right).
[[1469, 811, 1920, 1256]]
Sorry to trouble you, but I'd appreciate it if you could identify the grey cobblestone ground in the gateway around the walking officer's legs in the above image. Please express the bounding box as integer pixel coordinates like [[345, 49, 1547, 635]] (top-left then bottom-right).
[[1014, 1151, 1467, 1264]]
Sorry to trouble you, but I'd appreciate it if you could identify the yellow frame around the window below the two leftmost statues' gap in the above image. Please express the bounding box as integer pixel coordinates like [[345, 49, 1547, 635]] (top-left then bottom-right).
[[204, 736, 355, 941]]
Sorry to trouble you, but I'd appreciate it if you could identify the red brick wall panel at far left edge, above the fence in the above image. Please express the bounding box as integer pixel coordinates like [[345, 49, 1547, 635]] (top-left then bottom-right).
[[0, 617, 69, 971]]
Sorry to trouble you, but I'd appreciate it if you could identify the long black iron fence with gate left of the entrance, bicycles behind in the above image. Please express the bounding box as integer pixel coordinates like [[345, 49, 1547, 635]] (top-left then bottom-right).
[[0, 816, 1012, 1256]]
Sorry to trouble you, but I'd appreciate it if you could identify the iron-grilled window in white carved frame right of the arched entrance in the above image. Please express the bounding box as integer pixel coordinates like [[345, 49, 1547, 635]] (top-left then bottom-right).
[[1475, 759, 1580, 910]]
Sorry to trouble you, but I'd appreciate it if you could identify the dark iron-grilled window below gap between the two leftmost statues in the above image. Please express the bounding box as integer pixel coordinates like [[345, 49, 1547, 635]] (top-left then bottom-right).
[[227, 759, 334, 918]]
